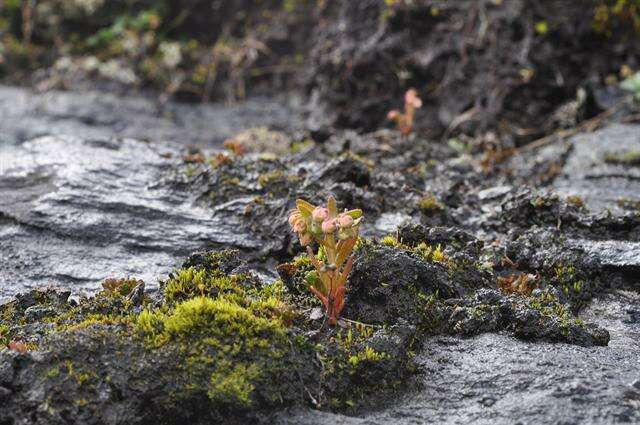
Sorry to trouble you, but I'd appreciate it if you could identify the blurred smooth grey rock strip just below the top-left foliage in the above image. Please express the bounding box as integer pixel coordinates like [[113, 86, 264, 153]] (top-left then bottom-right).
[[0, 85, 297, 147]]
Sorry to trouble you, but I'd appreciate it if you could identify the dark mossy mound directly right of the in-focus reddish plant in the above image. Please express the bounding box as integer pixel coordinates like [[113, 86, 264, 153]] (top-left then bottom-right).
[[280, 225, 609, 346]]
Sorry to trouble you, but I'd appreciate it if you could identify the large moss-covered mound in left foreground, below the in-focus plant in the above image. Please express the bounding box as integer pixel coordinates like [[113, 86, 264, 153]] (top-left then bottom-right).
[[0, 247, 416, 424]]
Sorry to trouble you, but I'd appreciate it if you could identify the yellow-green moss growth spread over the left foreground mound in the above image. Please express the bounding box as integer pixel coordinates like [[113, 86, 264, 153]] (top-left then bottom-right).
[[6, 248, 420, 417]]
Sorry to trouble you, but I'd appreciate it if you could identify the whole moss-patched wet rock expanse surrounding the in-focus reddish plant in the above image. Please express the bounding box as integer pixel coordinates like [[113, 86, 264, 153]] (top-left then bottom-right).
[[0, 94, 640, 424]]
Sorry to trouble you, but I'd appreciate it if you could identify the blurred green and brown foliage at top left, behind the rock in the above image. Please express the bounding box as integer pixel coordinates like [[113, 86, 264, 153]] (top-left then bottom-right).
[[0, 0, 318, 100]]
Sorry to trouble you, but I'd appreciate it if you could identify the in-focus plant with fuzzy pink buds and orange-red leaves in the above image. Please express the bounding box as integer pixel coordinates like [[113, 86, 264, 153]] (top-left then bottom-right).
[[289, 196, 362, 325]]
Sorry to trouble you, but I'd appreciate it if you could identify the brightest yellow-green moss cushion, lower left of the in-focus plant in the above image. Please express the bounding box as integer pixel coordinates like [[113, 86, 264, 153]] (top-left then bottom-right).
[[137, 296, 287, 406]]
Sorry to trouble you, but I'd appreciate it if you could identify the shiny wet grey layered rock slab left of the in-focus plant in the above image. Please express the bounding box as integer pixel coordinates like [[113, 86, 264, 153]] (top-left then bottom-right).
[[0, 137, 279, 299]]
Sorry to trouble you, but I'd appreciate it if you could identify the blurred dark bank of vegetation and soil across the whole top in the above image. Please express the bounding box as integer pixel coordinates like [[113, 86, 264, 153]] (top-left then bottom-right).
[[0, 0, 640, 135]]
